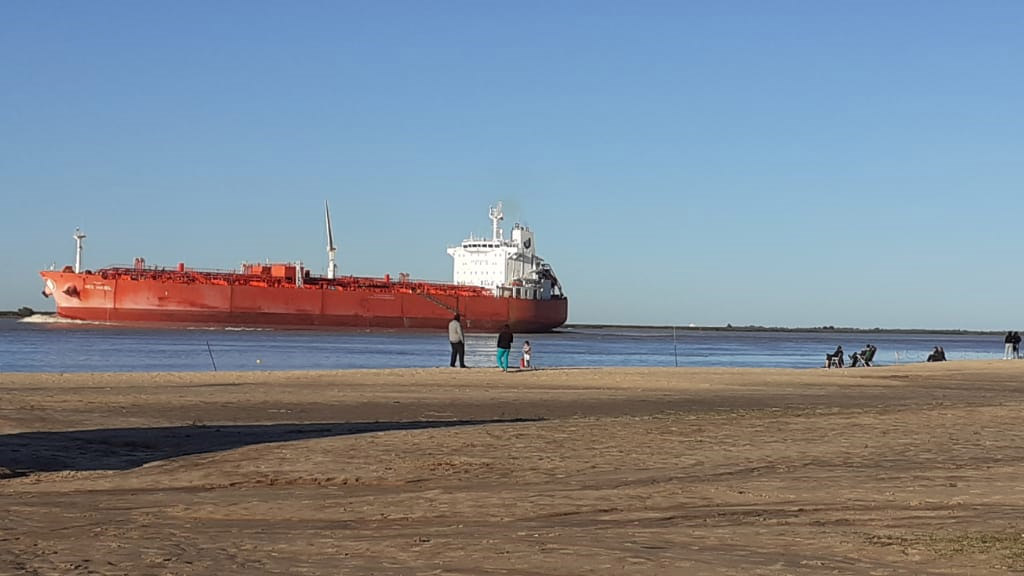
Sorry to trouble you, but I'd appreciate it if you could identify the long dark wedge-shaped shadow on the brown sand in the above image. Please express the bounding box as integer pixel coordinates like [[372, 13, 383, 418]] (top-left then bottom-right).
[[0, 418, 538, 478]]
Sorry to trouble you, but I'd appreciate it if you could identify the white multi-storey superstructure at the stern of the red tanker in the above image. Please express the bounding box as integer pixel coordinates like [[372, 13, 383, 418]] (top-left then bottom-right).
[[447, 202, 563, 300]]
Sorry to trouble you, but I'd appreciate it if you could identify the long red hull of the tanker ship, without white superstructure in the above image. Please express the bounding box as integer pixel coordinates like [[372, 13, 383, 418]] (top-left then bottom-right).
[[40, 271, 568, 332]]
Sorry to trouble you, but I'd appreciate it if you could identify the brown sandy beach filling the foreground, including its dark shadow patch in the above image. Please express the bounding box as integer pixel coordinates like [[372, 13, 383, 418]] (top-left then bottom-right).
[[0, 361, 1024, 575]]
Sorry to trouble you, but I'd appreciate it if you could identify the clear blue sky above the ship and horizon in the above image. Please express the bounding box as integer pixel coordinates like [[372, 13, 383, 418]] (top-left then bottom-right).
[[0, 0, 1024, 329]]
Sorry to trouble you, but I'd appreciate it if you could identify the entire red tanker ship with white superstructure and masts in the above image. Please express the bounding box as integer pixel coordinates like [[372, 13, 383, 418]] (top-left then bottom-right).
[[40, 202, 568, 332]]
